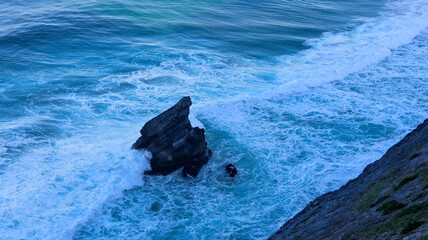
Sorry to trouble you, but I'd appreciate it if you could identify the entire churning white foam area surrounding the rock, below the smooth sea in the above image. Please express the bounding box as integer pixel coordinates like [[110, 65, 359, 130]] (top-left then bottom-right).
[[0, 0, 428, 239]]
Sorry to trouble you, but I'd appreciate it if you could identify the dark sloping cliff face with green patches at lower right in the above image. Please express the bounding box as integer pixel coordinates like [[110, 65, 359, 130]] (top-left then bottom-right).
[[269, 119, 428, 240]]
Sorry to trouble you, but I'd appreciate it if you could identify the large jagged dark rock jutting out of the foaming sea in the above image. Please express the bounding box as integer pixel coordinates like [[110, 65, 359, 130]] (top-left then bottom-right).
[[132, 97, 212, 177]]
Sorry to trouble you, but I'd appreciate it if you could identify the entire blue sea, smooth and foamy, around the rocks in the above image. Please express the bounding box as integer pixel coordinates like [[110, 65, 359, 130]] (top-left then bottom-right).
[[0, 0, 428, 239]]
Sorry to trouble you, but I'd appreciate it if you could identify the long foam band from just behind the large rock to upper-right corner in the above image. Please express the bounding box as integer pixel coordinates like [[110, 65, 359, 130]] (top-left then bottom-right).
[[99, 0, 428, 111]]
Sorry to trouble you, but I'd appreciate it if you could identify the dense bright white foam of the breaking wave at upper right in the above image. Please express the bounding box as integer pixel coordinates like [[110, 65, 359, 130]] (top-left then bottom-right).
[[268, 0, 428, 97]]
